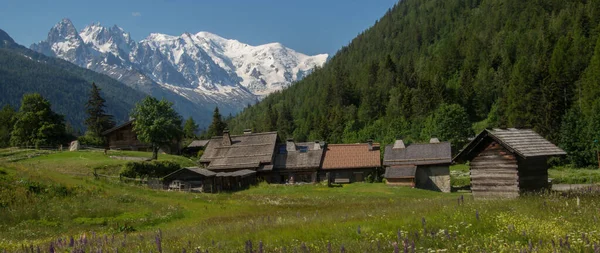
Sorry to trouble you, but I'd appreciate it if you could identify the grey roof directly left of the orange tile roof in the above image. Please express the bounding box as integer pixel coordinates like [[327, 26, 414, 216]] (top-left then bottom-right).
[[273, 142, 324, 170]]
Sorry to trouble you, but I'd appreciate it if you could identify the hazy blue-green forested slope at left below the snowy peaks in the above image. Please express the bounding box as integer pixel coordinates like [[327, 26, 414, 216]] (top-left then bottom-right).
[[0, 30, 145, 130]]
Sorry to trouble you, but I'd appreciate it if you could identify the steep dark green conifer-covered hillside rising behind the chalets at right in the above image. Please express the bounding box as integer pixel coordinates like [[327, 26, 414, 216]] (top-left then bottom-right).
[[229, 0, 600, 166]]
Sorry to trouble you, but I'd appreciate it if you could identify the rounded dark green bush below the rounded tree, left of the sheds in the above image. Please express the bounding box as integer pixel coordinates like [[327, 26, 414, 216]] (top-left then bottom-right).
[[119, 161, 181, 179]]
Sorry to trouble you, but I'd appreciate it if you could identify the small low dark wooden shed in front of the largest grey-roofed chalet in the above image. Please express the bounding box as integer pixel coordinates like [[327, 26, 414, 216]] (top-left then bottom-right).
[[162, 167, 217, 192]]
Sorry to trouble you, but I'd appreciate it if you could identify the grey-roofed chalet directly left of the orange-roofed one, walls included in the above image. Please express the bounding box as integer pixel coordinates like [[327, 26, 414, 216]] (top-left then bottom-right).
[[268, 139, 324, 183]]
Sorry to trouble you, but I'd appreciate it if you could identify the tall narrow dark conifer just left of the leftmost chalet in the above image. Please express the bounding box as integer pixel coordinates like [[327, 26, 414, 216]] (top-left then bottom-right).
[[85, 83, 115, 137]]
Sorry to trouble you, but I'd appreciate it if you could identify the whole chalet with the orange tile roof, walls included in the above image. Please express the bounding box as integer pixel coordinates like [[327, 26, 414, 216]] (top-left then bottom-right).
[[319, 141, 381, 183]]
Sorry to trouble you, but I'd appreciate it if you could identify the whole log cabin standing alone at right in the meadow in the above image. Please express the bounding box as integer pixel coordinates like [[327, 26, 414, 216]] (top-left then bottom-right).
[[454, 128, 566, 198]]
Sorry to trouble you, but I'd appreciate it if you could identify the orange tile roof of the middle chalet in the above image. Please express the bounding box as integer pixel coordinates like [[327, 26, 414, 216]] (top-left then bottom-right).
[[322, 143, 381, 169]]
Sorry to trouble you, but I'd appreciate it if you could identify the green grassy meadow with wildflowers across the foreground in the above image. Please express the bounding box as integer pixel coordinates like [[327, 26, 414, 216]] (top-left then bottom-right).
[[0, 150, 600, 252]]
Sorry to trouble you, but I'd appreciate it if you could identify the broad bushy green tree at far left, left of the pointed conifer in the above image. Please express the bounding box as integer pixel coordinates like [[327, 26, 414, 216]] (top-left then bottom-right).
[[10, 93, 67, 147]]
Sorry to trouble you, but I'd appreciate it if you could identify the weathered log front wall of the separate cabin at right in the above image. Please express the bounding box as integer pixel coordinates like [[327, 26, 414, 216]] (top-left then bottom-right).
[[470, 141, 519, 198]]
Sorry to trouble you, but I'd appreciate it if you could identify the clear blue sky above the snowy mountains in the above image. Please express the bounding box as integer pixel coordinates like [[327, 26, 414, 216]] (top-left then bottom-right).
[[0, 0, 397, 55]]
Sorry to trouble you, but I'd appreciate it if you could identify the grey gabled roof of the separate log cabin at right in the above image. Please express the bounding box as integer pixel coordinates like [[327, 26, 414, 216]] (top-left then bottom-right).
[[454, 128, 567, 161]]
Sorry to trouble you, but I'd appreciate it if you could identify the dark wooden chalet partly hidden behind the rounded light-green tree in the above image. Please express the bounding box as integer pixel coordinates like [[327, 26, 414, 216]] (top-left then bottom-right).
[[102, 120, 180, 154]]
